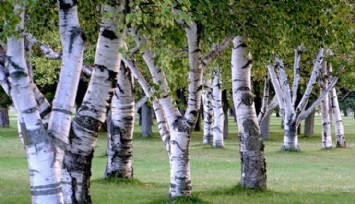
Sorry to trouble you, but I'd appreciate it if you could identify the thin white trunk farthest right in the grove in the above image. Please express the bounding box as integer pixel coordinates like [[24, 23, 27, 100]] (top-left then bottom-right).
[[330, 88, 346, 147]]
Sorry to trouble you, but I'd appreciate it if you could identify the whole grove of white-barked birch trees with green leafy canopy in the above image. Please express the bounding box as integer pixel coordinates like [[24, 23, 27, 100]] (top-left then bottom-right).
[[0, 0, 355, 203]]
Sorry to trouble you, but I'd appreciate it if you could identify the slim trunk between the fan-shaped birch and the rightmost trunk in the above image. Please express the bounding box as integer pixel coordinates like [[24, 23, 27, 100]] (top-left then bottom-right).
[[319, 62, 333, 149]]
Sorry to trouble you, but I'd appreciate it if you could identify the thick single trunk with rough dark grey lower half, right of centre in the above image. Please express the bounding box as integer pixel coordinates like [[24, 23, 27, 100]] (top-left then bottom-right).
[[232, 37, 266, 189]]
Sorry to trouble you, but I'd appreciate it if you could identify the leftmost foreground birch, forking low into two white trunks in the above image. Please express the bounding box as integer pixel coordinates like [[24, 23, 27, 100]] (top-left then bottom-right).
[[3, 1, 84, 203]]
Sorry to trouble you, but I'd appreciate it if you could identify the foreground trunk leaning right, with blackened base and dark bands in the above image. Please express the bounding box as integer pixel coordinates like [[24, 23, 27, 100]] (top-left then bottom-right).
[[63, 5, 123, 203]]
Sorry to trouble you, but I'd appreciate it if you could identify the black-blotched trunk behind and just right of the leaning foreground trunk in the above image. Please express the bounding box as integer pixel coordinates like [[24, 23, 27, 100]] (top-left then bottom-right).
[[104, 63, 134, 179]]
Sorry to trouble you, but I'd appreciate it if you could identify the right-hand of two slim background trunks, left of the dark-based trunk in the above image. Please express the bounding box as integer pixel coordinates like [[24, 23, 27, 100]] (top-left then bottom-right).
[[212, 68, 224, 148]]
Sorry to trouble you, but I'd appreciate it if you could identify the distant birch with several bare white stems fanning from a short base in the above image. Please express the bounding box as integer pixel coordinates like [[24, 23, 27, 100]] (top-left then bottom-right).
[[268, 47, 337, 151]]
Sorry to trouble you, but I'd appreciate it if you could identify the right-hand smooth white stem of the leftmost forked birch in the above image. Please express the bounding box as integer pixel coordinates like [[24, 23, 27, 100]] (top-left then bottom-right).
[[48, 1, 84, 168]]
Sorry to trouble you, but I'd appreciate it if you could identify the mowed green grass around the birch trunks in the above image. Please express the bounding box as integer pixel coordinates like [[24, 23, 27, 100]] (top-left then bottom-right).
[[0, 112, 355, 204]]
